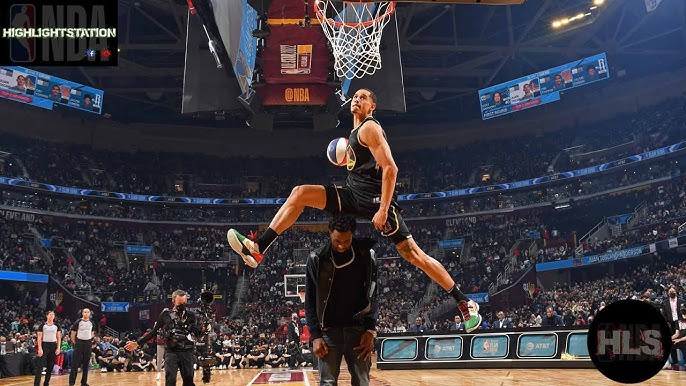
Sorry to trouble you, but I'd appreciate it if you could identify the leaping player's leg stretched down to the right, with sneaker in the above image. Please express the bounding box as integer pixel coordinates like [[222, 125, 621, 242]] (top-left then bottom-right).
[[381, 205, 482, 332]]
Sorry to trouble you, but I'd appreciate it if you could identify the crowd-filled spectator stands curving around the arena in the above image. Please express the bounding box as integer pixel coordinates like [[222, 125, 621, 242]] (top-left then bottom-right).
[[0, 96, 686, 376]]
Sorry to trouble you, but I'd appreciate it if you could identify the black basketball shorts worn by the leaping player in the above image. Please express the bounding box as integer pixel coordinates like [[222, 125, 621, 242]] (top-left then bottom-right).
[[324, 185, 412, 244]]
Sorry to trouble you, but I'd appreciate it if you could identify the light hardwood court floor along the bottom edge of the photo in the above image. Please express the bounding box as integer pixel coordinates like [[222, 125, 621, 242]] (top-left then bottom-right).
[[0, 368, 686, 386]]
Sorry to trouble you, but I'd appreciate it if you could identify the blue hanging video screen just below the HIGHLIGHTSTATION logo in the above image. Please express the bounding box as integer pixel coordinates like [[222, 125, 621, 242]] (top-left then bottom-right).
[[0, 66, 103, 114]]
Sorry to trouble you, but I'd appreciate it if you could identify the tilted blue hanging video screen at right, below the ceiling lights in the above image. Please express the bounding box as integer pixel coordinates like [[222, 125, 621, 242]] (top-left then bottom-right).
[[479, 52, 610, 120]]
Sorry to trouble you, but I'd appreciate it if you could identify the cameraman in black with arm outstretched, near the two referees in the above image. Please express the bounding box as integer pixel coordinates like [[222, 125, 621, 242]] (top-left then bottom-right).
[[125, 290, 202, 386]]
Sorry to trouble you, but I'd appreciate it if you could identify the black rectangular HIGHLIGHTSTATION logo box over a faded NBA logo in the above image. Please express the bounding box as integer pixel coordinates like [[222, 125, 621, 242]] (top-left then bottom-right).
[[0, 0, 119, 67]]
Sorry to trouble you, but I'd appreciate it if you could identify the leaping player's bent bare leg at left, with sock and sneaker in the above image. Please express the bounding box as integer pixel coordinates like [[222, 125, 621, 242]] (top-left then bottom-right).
[[226, 185, 327, 268]]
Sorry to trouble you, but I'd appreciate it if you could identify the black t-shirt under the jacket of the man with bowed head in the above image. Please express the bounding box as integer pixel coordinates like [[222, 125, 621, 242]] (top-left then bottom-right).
[[323, 248, 366, 327]]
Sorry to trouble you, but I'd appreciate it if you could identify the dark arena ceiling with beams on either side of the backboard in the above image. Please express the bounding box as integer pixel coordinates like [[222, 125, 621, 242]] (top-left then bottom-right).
[[36, 0, 686, 126]]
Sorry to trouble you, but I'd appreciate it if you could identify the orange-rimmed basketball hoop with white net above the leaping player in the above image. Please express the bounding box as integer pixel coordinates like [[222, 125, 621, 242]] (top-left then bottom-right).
[[314, 0, 395, 80]]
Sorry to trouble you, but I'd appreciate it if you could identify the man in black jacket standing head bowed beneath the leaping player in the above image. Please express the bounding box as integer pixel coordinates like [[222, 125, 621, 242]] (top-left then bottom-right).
[[305, 215, 378, 386]]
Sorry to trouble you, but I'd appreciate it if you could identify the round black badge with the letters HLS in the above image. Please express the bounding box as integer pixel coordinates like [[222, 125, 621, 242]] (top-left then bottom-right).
[[588, 300, 672, 383]]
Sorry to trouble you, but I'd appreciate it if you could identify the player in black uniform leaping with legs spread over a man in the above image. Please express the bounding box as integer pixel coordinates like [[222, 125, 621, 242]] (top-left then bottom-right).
[[227, 89, 481, 332]]
